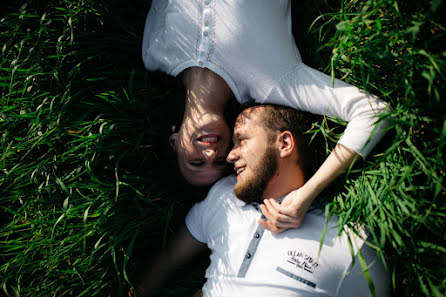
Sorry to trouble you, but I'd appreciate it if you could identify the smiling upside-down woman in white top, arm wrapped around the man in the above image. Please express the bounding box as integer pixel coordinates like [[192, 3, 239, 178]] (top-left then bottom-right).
[[143, 0, 386, 232]]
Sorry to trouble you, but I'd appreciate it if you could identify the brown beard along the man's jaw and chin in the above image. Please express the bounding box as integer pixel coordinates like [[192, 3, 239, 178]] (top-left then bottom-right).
[[234, 147, 277, 203]]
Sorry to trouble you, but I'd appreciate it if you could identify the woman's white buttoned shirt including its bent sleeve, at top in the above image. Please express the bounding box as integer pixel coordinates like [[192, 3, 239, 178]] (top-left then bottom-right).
[[142, 0, 386, 158]]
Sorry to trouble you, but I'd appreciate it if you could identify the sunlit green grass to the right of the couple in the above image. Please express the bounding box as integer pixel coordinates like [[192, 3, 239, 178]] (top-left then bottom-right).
[[306, 0, 446, 296]]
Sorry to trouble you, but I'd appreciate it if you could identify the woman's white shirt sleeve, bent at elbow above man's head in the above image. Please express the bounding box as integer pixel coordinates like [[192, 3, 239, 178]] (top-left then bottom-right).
[[262, 63, 387, 158]]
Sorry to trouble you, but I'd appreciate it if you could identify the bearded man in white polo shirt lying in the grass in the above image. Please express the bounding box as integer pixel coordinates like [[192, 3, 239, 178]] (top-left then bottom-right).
[[137, 105, 388, 297]]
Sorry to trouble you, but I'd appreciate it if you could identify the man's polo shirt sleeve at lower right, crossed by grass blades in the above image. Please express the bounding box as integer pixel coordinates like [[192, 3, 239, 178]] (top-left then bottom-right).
[[336, 244, 390, 297]]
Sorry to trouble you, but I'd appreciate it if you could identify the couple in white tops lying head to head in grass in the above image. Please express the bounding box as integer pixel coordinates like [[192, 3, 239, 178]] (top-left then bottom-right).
[[137, 0, 386, 296]]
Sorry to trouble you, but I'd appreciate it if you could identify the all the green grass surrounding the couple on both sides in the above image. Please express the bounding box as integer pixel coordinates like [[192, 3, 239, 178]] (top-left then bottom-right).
[[0, 0, 446, 297]]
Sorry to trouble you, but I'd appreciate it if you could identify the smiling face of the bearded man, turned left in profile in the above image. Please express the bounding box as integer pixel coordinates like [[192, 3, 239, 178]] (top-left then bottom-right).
[[227, 106, 277, 202]]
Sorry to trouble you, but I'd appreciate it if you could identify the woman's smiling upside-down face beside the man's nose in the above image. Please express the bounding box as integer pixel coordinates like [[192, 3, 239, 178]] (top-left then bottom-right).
[[170, 114, 231, 186]]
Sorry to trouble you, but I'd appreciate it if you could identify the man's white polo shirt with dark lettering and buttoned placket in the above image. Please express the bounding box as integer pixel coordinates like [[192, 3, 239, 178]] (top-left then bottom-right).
[[186, 176, 388, 297]]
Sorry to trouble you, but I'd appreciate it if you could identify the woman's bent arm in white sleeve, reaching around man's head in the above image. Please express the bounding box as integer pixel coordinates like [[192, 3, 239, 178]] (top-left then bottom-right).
[[259, 56, 387, 232]]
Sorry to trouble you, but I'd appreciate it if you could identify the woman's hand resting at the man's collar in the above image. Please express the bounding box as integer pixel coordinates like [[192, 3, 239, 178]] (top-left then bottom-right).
[[259, 185, 313, 233]]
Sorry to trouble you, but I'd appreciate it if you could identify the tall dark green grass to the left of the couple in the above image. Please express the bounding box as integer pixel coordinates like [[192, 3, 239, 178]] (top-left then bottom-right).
[[0, 1, 182, 296]]
